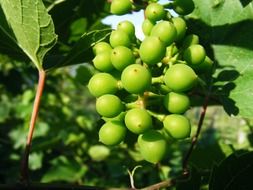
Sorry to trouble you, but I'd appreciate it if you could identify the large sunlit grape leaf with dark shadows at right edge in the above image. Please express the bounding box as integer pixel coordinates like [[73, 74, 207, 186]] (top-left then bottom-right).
[[189, 0, 253, 118]]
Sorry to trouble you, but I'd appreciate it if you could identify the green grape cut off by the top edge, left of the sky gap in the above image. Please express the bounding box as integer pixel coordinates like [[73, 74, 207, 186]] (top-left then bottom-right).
[[110, 0, 132, 15]]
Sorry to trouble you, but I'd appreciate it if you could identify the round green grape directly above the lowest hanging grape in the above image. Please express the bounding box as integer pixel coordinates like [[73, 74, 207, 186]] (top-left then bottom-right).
[[125, 108, 152, 134]]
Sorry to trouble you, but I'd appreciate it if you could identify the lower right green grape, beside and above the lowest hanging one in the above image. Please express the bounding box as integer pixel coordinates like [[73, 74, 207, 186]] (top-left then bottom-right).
[[163, 114, 191, 139]]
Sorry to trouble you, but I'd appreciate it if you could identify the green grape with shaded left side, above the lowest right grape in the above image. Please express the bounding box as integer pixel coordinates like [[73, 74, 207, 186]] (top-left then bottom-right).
[[163, 92, 190, 114]]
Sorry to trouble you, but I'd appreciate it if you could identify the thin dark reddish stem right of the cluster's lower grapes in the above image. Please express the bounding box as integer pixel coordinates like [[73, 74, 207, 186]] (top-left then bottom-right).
[[182, 91, 209, 173]]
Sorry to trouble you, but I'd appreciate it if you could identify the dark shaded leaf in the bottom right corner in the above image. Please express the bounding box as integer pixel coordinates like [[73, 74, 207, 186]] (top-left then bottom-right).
[[209, 151, 253, 190]]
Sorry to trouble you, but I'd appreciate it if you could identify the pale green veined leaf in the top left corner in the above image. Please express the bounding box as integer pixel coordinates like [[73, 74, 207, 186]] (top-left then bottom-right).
[[0, 0, 57, 70]]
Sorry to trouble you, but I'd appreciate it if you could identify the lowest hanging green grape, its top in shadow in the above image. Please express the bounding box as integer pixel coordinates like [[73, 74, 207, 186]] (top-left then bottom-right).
[[138, 130, 167, 164]]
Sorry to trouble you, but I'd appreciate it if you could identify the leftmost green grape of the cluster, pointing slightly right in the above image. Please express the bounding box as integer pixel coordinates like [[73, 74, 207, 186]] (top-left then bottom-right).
[[88, 73, 118, 97]]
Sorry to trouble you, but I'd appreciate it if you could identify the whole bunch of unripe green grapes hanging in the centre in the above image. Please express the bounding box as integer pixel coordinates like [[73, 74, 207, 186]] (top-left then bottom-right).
[[88, 0, 212, 163]]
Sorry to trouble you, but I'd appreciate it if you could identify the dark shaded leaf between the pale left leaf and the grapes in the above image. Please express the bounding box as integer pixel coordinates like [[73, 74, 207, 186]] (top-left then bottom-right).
[[45, 29, 111, 70]]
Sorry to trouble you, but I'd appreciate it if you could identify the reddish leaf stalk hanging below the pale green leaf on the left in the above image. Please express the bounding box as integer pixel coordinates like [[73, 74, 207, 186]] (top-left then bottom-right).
[[20, 70, 46, 184]]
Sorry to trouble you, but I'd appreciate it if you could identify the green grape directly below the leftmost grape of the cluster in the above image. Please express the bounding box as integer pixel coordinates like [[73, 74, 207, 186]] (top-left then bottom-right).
[[96, 94, 124, 118]]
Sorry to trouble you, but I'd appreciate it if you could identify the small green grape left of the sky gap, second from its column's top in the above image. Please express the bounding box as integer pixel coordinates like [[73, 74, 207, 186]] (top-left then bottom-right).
[[109, 30, 131, 48]]
